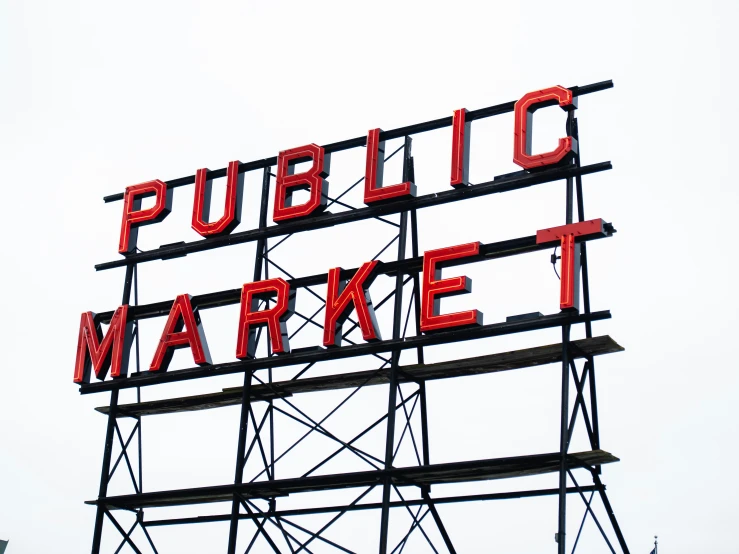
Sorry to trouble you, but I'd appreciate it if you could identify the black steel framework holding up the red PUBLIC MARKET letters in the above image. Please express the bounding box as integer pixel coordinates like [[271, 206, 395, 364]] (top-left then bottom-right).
[[81, 82, 629, 554]]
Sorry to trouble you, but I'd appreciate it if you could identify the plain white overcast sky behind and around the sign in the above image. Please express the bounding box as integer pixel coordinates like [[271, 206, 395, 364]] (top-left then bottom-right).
[[0, 0, 739, 554]]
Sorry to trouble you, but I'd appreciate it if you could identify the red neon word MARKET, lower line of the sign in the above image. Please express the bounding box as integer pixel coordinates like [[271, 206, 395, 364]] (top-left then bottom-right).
[[74, 219, 620, 383]]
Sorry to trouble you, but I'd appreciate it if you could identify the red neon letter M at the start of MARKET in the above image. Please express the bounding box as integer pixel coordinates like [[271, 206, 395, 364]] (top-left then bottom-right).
[[74, 304, 133, 383]]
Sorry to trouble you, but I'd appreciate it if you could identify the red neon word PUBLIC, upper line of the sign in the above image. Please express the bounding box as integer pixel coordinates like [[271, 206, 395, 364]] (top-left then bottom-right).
[[111, 86, 588, 248]]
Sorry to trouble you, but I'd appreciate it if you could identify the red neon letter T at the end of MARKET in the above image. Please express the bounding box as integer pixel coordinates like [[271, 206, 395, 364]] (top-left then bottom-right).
[[536, 219, 605, 310]]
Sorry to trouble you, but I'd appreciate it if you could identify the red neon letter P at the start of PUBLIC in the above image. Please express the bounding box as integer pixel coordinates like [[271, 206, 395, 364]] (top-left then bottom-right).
[[118, 179, 172, 254]]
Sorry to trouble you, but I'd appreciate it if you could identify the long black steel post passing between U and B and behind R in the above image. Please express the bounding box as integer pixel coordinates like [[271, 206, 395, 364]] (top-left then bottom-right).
[[228, 166, 272, 554]]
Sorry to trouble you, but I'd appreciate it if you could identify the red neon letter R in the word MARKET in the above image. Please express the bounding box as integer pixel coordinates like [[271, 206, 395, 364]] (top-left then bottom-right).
[[236, 278, 295, 360]]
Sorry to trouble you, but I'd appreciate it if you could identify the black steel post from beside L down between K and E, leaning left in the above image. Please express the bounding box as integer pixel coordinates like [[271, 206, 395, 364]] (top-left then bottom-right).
[[380, 136, 413, 554]]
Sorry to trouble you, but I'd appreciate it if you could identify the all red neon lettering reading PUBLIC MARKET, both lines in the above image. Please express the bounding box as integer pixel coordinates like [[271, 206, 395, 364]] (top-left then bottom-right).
[[74, 86, 620, 383]]
